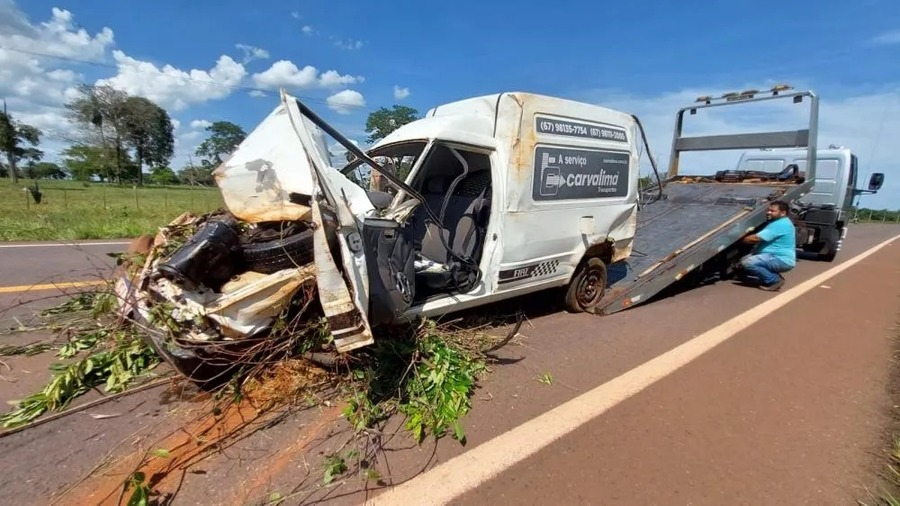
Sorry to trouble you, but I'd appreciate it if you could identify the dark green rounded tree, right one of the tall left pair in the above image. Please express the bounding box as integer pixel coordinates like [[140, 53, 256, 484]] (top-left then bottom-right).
[[122, 97, 175, 185]]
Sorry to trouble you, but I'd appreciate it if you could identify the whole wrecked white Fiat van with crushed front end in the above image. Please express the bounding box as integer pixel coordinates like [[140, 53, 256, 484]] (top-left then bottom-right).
[[130, 93, 642, 360]]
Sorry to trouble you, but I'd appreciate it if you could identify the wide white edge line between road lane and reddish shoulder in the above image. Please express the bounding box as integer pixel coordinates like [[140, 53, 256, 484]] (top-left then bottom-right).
[[367, 235, 900, 505]]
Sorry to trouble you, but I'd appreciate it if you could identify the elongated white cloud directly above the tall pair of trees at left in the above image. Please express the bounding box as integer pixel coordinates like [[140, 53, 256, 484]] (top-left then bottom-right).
[[97, 51, 247, 111]]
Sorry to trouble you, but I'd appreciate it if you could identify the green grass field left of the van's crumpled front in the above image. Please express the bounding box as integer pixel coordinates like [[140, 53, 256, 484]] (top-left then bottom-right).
[[0, 179, 224, 241]]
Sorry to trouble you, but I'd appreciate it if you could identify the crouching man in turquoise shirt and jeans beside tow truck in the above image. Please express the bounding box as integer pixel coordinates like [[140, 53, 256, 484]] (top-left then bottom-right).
[[741, 201, 797, 291]]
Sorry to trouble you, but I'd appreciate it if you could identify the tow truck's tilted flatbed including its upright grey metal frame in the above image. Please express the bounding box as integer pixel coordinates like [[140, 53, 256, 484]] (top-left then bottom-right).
[[596, 86, 819, 314]]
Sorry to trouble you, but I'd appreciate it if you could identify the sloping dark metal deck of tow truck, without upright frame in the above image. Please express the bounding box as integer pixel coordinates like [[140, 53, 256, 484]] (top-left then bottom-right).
[[597, 176, 811, 314]]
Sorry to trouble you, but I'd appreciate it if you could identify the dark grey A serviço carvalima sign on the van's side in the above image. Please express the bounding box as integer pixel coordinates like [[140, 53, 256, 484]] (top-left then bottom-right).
[[532, 146, 631, 200]]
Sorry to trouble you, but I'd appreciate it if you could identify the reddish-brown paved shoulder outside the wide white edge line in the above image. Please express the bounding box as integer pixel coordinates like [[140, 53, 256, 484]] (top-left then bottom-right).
[[457, 237, 900, 504]]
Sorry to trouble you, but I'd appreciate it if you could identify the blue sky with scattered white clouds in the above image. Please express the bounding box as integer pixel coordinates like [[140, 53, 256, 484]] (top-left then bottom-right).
[[0, 0, 900, 208]]
